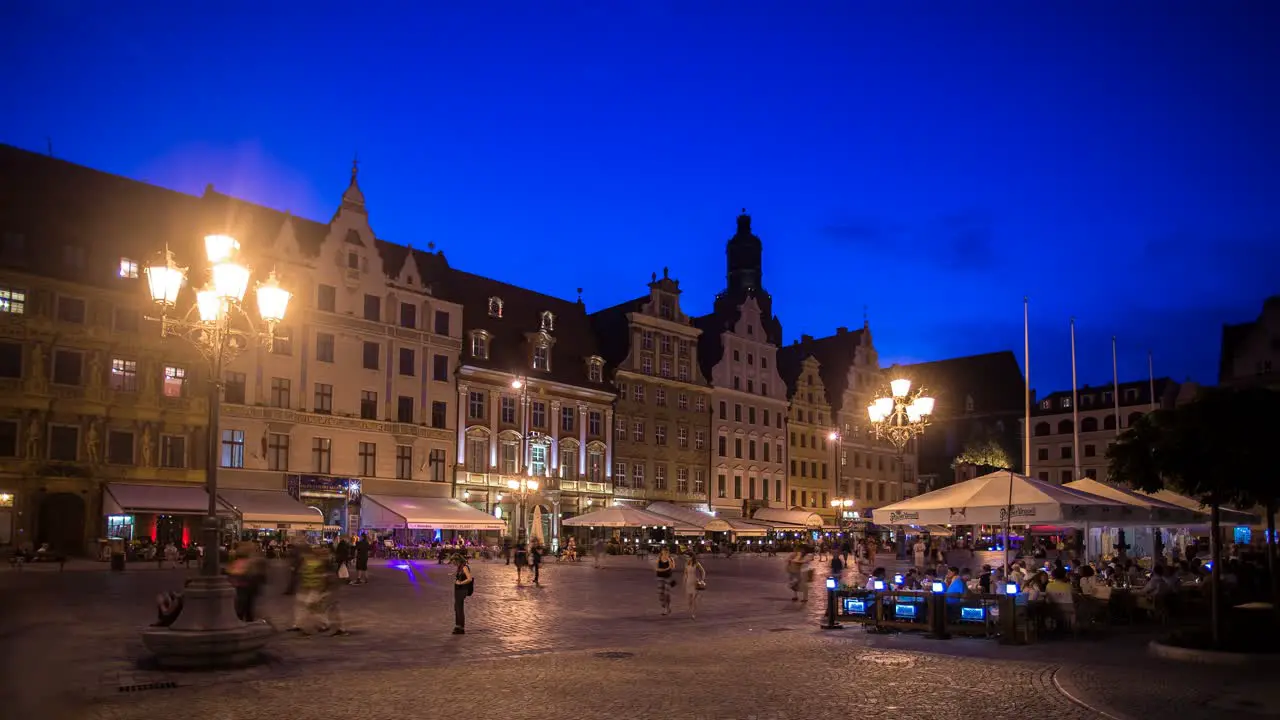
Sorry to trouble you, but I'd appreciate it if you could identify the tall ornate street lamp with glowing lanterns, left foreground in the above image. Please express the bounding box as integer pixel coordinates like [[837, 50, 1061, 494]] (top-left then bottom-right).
[[143, 234, 292, 666]]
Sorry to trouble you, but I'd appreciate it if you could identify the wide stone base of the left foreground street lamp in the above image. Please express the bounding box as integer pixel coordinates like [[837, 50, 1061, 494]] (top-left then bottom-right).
[[142, 575, 275, 667]]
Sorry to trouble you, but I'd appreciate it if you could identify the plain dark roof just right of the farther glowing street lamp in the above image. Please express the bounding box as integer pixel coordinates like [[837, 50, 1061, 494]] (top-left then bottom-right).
[[891, 350, 1027, 419]]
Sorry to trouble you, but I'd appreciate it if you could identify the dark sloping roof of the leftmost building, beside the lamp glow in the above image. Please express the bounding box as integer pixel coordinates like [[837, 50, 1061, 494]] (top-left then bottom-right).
[[0, 145, 206, 288]]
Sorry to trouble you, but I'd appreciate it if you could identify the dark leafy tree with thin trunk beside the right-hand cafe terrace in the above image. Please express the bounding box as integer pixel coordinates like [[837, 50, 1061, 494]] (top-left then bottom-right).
[[1107, 389, 1275, 644]]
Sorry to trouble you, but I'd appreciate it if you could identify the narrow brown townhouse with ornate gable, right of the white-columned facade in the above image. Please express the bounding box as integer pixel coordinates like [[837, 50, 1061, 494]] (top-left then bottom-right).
[[591, 268, 712, 509]]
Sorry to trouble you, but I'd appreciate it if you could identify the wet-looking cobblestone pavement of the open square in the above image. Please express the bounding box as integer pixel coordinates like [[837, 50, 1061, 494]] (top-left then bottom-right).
[[0, 557, 1280, 720]]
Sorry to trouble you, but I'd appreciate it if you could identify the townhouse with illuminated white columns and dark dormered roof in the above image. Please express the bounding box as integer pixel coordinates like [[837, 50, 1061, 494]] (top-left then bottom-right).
[[444, 270, 614, 541]]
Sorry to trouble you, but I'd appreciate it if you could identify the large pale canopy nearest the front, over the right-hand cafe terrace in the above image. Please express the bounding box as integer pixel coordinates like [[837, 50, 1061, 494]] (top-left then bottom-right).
[[876, 471, 1138, 525]]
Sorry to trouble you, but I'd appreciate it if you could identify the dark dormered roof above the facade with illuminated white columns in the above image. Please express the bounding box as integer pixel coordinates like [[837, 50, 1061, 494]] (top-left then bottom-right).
[[436, 269, 607, 389]]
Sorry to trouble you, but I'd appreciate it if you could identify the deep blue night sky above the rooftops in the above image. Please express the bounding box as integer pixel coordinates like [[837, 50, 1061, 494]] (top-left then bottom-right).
[[0, 0, 1280, 392]]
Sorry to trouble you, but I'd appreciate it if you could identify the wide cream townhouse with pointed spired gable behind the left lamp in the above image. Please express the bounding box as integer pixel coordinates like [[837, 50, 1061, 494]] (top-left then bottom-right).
[[204, 168, 462, 532]]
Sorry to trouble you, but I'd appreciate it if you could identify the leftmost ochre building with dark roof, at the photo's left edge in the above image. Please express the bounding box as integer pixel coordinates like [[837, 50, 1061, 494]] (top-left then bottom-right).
[[0, 146, 209, 553]]
